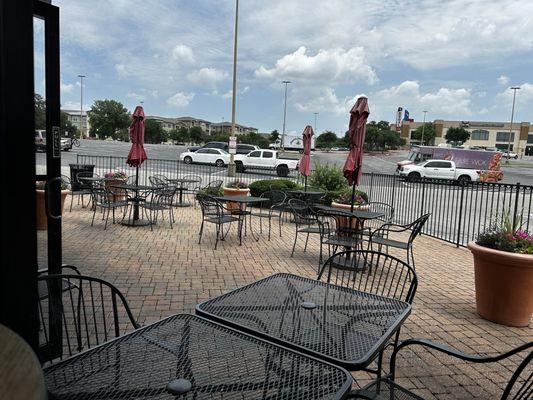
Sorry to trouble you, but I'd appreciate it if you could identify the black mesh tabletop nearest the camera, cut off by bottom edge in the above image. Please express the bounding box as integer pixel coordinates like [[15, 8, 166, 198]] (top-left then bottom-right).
[[44, 314, 352, 400]]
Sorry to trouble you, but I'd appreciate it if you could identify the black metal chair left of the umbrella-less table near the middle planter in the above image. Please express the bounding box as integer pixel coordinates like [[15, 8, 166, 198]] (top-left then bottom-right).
[[197, 194, 242, 250]]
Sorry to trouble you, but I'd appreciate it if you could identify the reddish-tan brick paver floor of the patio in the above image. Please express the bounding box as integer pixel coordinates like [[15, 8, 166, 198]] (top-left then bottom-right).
[[39, 200, 533, 399]]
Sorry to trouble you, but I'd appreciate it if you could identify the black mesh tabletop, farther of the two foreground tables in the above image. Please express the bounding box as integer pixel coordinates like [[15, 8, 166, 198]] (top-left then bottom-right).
[[196, 274, 411, 370]]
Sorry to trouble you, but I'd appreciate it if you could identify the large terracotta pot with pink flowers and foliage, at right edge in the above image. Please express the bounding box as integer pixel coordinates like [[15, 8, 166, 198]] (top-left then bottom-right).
[[468, 214, 533, 327]]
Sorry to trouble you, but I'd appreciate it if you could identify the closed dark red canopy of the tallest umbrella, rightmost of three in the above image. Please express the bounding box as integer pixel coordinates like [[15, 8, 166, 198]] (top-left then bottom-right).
[[343, 97, 370, 185]]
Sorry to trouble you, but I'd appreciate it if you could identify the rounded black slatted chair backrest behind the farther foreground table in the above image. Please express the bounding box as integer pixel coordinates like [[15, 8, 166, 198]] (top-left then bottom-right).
[[318, 250, 418, 303]]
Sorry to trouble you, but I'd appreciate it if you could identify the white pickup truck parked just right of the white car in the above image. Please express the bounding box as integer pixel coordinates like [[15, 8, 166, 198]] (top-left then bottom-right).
[[235, 150, 298, 176]]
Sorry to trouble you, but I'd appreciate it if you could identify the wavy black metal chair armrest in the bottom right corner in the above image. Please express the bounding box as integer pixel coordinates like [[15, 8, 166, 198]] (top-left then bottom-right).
[[390, 339, 533, 378]]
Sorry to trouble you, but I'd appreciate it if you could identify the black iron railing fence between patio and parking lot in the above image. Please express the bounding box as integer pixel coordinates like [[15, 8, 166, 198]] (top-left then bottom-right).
[[77, 155, 533, 246]]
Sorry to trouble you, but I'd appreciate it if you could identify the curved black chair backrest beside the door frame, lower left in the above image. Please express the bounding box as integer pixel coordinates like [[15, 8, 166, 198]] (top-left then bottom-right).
[[37, 274, 140, 363]]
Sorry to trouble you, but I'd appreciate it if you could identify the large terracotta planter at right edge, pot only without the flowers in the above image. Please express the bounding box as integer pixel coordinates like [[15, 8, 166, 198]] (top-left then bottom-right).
[[468, 242, 533, 326]]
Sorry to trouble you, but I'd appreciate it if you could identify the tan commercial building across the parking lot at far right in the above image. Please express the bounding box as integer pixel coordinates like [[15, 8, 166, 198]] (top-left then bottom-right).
[[392, 119, 533, 156]]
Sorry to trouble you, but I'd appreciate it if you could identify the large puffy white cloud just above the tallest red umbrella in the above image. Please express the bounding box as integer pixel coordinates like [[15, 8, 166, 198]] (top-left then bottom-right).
[[255, 46, 378, 84]]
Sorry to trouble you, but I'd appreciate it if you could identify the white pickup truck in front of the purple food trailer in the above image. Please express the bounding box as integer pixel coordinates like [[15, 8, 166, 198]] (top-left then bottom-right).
[[398, 160, 479, 184]]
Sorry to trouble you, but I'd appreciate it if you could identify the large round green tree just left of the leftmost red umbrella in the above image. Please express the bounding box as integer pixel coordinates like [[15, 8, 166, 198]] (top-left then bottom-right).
[[87, 100, 131, 139]]
